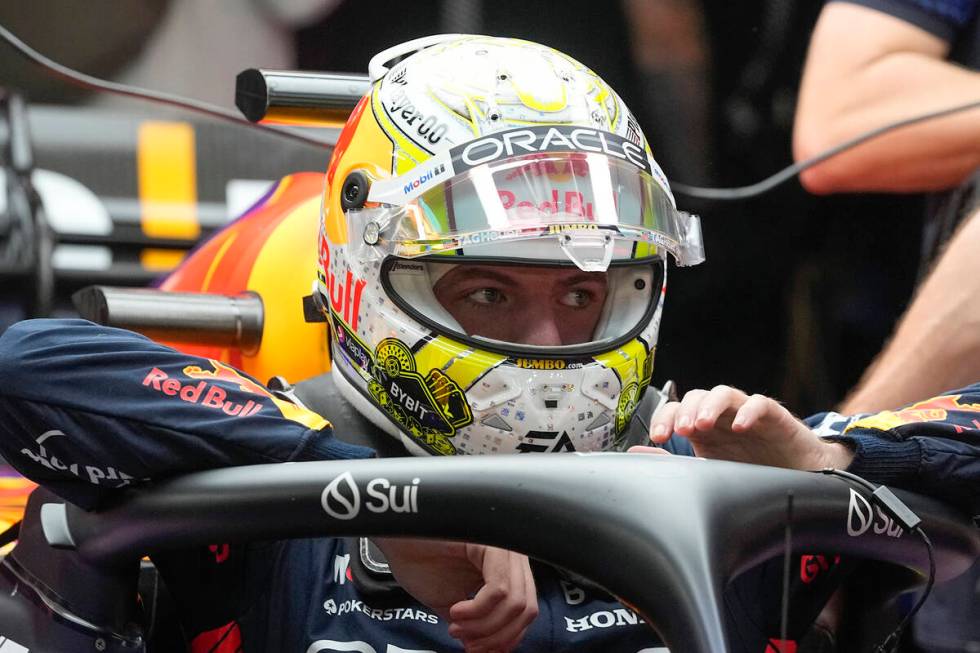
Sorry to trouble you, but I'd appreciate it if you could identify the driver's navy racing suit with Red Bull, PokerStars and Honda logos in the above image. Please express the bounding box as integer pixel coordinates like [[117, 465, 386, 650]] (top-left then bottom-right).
[[0, 320, 980, 653]]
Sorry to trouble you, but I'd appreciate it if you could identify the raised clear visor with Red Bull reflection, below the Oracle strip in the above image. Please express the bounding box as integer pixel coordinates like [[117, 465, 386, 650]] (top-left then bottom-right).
[[360, 151, 704, 270]]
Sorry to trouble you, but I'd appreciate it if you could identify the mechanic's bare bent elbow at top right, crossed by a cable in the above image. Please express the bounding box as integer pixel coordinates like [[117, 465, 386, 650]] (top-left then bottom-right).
[[793, 2, 980, 194]]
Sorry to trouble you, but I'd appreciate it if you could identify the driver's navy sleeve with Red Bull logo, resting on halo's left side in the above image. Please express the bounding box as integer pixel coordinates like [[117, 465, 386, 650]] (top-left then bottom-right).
[[0, 320, 371, 508]]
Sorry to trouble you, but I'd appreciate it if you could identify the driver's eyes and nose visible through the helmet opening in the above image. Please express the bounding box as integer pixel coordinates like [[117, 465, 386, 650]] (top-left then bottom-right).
[[433, 265, 606, 346]]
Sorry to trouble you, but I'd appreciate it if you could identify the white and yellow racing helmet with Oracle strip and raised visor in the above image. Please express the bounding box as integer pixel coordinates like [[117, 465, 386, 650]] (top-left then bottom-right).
[[314, 35, 703, 455]]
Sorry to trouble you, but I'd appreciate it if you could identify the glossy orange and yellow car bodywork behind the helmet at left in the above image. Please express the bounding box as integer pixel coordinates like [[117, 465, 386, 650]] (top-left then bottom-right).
[[0, 172, 330, 531]]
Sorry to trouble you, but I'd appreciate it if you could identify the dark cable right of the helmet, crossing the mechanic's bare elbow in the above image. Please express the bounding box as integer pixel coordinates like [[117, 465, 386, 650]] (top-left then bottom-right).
[[670, 100, 980, 200]]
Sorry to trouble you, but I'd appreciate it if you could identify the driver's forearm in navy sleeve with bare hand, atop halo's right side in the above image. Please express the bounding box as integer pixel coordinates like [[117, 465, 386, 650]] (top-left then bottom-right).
[[650, 383, 980, 515]]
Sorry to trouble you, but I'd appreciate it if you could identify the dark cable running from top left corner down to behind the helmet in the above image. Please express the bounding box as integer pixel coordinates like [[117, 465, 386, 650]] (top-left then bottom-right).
[[0, 25, 334, 148]]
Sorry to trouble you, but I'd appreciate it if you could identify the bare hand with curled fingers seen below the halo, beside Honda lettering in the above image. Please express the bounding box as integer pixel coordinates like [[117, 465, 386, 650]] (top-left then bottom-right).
[[375, 539, 538, 653]]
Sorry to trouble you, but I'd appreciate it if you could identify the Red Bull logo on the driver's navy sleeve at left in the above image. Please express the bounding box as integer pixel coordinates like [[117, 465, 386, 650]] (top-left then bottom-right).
[[143, 361, 272, 417]]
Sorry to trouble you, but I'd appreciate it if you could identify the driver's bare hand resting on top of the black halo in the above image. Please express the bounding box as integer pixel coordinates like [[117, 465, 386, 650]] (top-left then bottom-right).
[[631, 385, 854, 470]]
